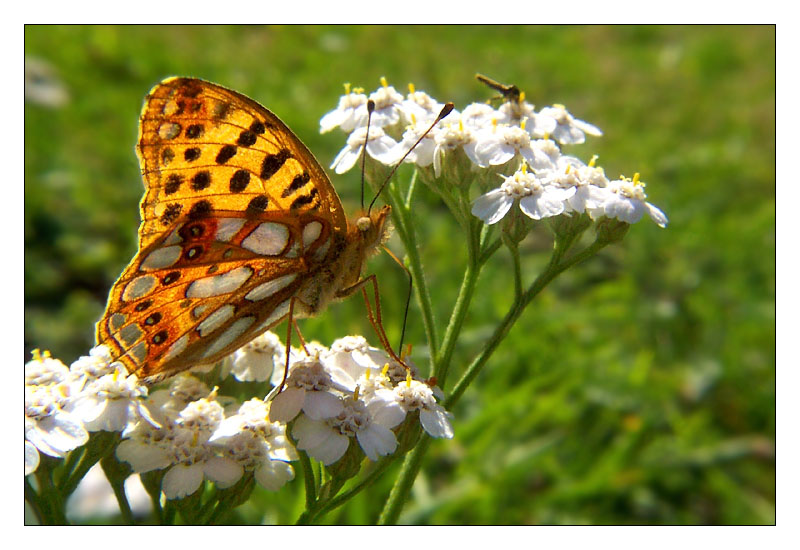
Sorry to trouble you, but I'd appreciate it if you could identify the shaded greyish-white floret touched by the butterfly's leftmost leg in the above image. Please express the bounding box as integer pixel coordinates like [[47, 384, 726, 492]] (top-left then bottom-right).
[[269, 358, 346, 423]]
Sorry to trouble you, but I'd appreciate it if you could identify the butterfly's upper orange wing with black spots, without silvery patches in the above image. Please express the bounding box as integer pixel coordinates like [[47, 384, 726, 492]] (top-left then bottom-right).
[[137, 78, 347, 245]]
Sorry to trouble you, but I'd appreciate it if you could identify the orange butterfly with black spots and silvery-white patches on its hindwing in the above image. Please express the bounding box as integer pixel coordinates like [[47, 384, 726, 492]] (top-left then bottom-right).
[[96, 77, 390, 384]]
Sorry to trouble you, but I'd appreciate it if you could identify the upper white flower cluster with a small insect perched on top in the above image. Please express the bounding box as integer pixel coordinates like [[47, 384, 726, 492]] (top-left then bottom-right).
[[320, 79, 667, 227]]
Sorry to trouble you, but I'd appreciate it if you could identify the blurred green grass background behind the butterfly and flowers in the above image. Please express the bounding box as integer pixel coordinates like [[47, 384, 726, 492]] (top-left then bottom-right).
[[24, 26, 775, 524]]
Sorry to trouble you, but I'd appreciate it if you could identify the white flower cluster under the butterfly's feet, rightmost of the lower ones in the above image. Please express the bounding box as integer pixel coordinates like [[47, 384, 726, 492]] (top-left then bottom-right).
[[270, 336, 453, 465]]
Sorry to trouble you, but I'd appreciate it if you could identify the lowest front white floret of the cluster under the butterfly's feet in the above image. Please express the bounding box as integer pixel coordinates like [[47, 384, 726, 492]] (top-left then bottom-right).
[[292, 397, 403, 466]]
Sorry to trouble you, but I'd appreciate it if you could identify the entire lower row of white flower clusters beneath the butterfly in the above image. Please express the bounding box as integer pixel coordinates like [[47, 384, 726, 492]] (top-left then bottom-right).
[[25, 332, 453, 499]]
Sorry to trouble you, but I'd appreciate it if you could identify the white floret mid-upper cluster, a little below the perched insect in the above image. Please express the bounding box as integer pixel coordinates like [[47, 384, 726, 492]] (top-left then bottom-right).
[[475, 126, 554, 170]]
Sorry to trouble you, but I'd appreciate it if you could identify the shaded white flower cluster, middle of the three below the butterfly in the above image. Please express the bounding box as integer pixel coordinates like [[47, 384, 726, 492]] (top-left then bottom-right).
[[117, 374, 297, 499]]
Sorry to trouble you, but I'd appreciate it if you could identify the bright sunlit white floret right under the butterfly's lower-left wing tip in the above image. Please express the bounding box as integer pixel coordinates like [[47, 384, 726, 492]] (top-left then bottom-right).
[[69, 363, 158, 432]]
